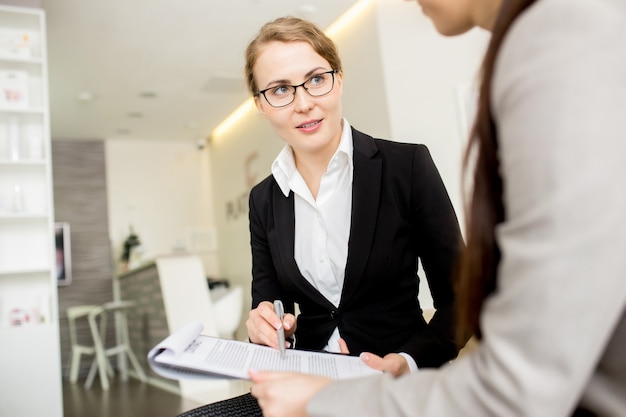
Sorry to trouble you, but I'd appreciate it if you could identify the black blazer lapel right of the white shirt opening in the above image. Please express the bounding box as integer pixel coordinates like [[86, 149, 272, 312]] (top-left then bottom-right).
[[341, 129, 382, 304]]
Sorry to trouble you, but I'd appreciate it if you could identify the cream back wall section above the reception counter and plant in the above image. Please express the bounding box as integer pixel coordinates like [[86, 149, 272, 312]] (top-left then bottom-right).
[[105, 139, 219, 276]]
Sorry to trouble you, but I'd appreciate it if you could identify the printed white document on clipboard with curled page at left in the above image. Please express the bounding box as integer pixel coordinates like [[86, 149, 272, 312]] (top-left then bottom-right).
[[148, 322, 381, 380]]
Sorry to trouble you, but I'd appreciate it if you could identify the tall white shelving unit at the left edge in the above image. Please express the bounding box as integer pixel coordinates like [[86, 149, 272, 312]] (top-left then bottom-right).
[[0, 6, 63, 417]]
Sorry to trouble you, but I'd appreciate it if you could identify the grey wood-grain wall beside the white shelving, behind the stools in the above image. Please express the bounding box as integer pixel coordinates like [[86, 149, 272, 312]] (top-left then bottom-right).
[[52, 139, 113, 377]]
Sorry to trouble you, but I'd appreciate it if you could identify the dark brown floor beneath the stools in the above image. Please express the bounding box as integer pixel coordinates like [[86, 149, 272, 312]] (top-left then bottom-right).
[[63, 378, 201, 417]]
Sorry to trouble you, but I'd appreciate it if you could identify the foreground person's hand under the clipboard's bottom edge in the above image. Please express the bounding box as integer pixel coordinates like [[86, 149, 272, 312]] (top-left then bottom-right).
[[249, 370, 331, 417]]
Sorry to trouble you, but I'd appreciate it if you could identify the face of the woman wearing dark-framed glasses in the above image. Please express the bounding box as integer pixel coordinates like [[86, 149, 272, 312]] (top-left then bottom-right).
[[253, 41, 343, 157]]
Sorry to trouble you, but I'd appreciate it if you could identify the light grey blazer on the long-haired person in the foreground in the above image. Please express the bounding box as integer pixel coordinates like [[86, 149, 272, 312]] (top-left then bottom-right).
[[308, 0, 626, 417]]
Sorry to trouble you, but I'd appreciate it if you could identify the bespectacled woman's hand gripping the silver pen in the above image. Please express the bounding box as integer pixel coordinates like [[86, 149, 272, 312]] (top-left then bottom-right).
[[246, 301, 296, 349]]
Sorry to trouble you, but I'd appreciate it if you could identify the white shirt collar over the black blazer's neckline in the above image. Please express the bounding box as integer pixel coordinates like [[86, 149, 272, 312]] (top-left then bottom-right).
[[272, 119, 354, 197]]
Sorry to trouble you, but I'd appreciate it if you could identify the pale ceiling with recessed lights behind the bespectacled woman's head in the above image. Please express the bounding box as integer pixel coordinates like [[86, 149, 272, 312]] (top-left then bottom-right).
[[41, 0, 357, 141]]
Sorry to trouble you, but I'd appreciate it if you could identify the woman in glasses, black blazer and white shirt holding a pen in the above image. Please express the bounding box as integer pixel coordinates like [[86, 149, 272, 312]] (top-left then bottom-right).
[[246, 17, 462, 375]]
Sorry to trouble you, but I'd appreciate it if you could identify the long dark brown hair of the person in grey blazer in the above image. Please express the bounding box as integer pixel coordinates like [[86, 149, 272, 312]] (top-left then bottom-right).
[[457, 0, 535, 341]]
